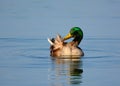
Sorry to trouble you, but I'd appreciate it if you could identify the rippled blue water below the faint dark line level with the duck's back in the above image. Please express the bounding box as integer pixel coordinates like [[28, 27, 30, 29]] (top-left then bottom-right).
[[0, 38, 120, 86]]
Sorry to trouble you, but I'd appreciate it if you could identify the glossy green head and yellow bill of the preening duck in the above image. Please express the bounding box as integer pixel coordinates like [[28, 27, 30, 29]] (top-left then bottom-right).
[[64, 27, 83, 41]]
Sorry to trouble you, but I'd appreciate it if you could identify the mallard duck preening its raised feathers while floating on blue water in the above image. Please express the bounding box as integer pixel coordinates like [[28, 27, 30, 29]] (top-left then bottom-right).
[[48, 27, 84, 57]]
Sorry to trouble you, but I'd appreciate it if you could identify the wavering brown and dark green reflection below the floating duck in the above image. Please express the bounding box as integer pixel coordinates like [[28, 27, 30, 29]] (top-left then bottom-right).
[[49, 56, 83, 86]]
